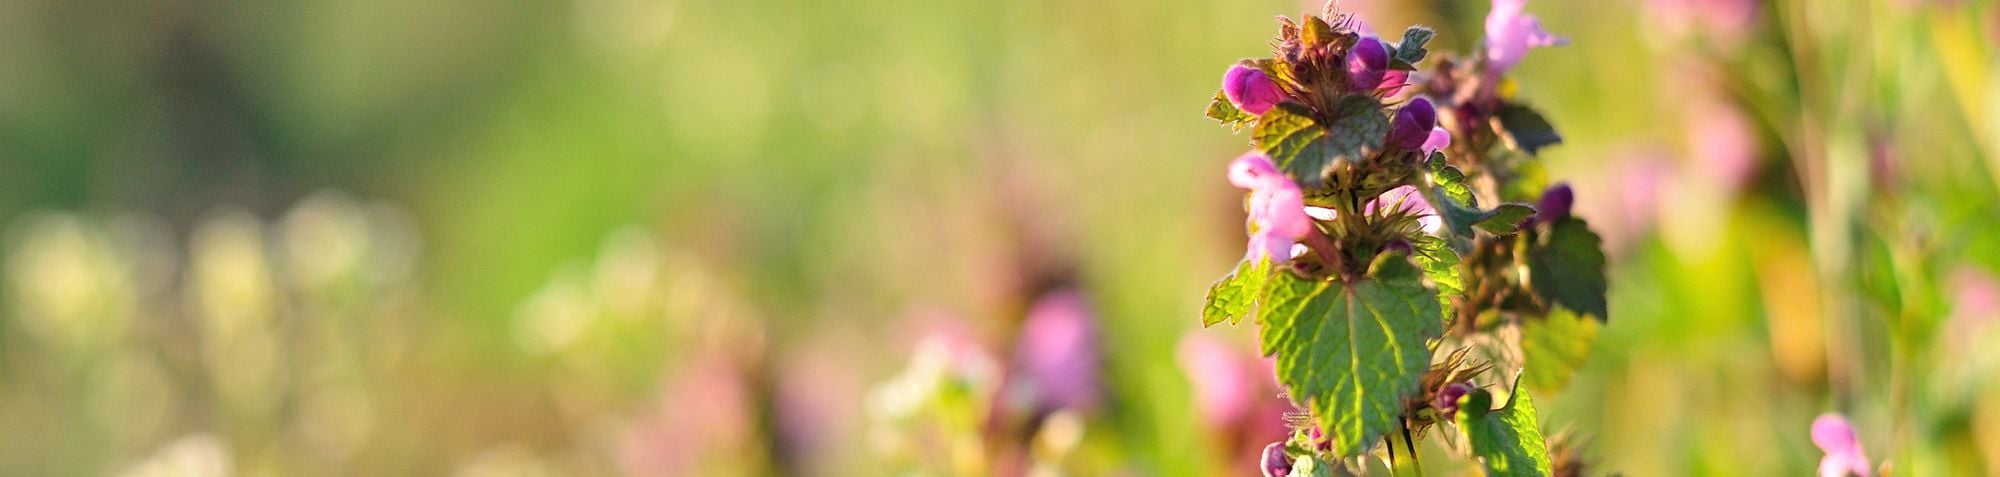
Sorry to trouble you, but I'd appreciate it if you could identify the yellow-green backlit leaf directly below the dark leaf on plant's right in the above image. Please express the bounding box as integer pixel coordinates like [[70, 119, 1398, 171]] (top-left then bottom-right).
[[1520, 307, 1598, 393]]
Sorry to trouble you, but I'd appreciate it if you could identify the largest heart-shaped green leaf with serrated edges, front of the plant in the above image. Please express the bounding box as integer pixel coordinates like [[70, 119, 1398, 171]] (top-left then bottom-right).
[[1258, 255, 1444, 457]]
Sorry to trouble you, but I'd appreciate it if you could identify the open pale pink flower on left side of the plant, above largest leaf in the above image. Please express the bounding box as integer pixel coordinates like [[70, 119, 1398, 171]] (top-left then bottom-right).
[[1230, 150, 1312, 263]]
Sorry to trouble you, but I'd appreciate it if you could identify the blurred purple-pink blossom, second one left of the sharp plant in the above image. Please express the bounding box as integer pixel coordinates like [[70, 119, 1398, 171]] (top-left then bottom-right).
[[1014, 291, 1102, 409]]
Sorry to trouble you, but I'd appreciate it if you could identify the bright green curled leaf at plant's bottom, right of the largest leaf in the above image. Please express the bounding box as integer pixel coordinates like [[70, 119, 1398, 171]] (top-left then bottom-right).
[[1458, 381, 1554, 477]]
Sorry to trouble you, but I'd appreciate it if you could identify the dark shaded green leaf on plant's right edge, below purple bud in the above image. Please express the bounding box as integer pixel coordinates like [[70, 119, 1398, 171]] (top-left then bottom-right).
[[1528, 216, 1610, 321]]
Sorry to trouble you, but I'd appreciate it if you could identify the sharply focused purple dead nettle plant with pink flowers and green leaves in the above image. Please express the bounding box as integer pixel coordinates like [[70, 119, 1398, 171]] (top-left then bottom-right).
[[1202, 0, 1608, 475]]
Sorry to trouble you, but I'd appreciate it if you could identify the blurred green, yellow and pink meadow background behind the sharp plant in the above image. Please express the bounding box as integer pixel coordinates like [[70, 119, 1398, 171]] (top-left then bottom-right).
[[0, 0, 2000, 475]]
